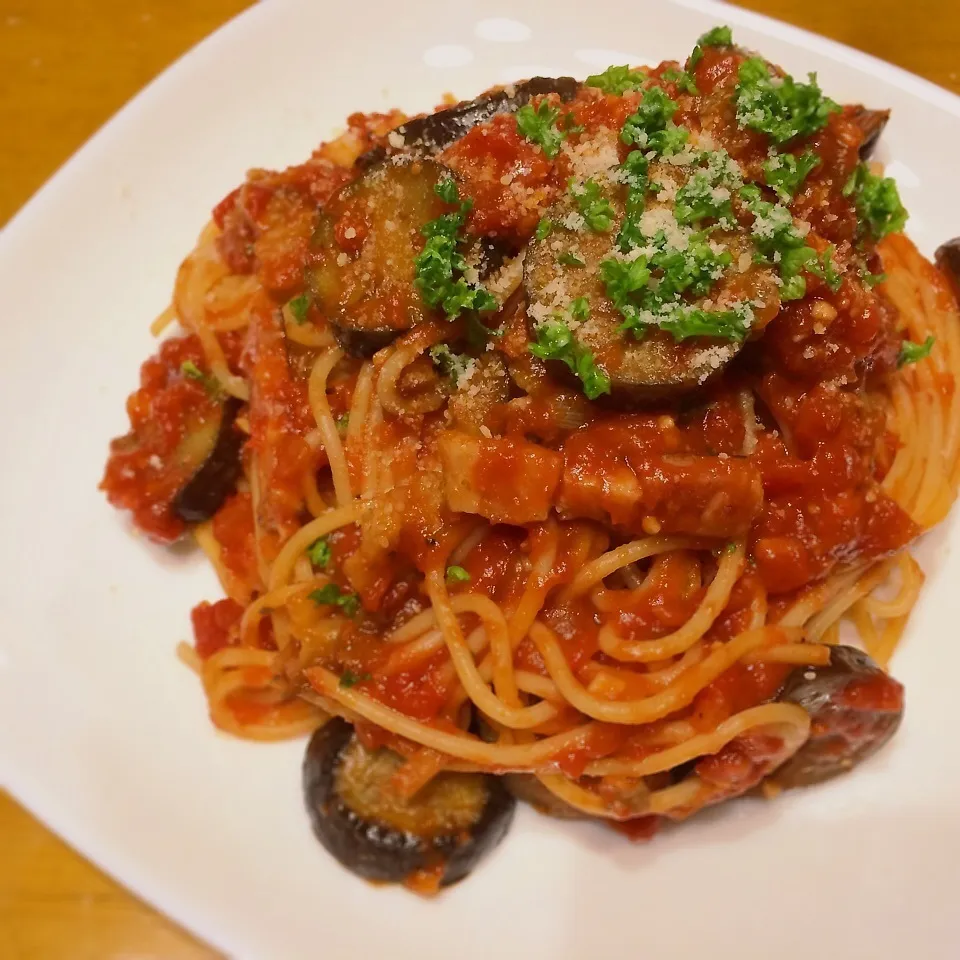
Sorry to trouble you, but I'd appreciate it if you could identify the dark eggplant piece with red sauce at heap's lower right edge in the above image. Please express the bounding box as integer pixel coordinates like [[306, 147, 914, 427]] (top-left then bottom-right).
[[773, 645, 903, 787]]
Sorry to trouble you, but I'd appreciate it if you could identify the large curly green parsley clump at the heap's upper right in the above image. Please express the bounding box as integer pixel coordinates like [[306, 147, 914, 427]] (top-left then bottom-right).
[[736, 57, 840, 143]]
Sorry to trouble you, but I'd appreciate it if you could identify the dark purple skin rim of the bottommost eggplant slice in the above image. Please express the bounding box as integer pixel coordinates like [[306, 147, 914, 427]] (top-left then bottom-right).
[[303, 717, 516, 887]]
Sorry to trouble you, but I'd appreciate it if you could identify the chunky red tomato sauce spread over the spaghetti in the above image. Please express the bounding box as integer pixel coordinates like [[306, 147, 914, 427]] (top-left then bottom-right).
[[102, 47, 928, 804]]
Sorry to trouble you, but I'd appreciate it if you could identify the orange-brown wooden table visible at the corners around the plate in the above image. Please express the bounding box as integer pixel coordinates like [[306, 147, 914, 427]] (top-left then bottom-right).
[[0, 0, 960, 960]]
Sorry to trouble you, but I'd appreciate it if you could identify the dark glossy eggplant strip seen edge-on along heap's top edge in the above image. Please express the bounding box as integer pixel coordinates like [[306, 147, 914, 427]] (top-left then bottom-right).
[[357, 77, 580, 169]]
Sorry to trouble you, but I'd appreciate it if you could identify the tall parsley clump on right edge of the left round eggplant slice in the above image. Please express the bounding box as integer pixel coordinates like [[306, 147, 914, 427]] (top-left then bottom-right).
[[414, 178, 497, 320]]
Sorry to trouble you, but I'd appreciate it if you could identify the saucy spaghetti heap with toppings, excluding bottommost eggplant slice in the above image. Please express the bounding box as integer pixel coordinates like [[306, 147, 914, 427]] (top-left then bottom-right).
[[103, 28, 960, 892]]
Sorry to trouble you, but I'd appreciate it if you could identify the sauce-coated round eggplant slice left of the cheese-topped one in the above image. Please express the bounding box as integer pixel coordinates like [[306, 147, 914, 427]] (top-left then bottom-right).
[[306, 160, 451, 357]]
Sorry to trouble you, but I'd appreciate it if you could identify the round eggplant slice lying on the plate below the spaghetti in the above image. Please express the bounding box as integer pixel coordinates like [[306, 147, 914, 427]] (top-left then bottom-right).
[[303, 718, 516, 886]]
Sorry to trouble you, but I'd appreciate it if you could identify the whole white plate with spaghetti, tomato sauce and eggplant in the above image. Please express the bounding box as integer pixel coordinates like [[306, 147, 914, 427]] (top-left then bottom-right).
[[0, 4, 960, 957]]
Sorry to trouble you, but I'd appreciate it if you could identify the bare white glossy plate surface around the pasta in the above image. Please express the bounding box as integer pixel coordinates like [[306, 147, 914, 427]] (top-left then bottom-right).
[[0, 0, 960, 960]]
